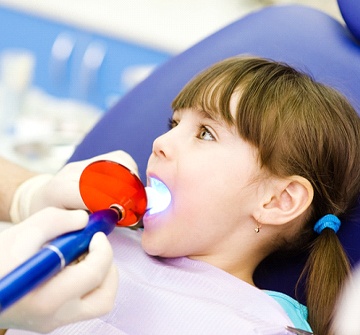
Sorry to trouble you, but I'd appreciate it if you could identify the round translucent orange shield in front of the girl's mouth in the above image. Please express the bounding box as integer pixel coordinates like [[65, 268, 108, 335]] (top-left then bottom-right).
[[79, 160, 147, 226]]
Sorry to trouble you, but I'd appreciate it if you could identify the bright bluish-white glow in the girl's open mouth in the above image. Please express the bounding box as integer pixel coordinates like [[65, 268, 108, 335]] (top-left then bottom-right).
[[145, 178, 171, 214]]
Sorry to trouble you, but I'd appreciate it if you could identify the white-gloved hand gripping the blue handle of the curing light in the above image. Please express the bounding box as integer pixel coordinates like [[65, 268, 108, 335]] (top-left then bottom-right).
[[0, 208, 118, 332]]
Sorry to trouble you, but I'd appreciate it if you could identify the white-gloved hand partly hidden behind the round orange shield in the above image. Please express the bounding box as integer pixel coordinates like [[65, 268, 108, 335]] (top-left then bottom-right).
[[10, 150, 138, 222]]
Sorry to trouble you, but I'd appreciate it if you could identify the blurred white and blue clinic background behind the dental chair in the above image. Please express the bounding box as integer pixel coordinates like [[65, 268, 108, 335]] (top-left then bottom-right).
[[0, 0, 342, 172]]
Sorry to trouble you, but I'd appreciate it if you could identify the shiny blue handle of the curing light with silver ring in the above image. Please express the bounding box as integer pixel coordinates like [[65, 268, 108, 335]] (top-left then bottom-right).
[[0, 209, 119, 313]]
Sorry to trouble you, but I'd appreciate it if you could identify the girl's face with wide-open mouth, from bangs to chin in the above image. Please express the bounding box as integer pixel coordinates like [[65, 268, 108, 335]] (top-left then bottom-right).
[[142, 96, 260, 263]]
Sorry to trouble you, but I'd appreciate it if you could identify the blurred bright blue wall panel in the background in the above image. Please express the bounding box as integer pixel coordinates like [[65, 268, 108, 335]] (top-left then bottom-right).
[[0, 6, 171, 110]]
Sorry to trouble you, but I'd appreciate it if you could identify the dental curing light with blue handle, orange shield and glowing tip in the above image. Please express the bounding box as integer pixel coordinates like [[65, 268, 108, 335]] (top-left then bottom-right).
[[0, 161, 171, 312]]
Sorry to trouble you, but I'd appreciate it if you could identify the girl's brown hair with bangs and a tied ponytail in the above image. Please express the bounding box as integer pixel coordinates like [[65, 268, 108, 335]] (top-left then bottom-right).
[[173, 57, 360, 335]]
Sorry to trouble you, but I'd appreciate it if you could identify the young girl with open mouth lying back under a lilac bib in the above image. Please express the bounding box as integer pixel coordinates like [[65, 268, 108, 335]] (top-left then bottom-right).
[[9, 57, 360, 335]]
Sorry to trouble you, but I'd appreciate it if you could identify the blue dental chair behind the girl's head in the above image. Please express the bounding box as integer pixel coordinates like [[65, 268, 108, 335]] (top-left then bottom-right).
[[70, 0, 360, 300]]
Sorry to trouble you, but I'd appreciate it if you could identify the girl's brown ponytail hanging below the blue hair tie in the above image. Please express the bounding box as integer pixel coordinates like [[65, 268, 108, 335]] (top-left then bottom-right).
[[300, 215, 350, 335]]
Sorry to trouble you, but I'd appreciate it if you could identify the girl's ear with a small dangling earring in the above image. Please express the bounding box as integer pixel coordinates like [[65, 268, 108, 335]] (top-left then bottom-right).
[[254, 176, 314, 225]]
